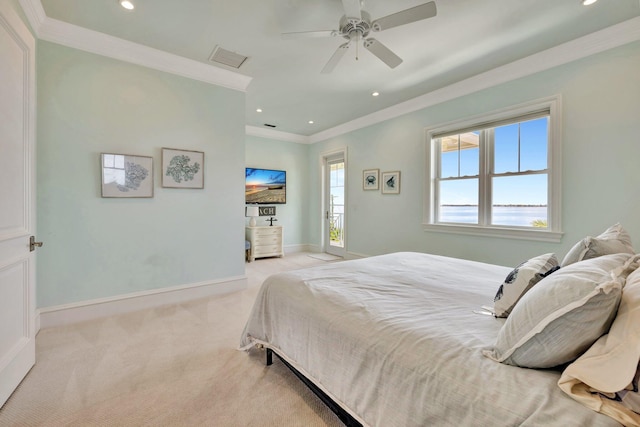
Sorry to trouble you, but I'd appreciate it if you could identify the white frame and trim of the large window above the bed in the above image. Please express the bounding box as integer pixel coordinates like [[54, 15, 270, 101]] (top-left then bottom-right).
[[422, 95, 563, 243]]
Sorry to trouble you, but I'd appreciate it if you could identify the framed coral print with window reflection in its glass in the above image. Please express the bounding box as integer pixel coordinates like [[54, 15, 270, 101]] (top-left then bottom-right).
[[100, 153, 153, 197]]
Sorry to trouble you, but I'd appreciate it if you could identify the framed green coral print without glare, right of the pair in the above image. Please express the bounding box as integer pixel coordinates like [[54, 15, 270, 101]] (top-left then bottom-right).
[[162, 148, 204, 188]]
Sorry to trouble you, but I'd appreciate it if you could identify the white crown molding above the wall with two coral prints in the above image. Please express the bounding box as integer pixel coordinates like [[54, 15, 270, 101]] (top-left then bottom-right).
[[19, 0, 251, 92]]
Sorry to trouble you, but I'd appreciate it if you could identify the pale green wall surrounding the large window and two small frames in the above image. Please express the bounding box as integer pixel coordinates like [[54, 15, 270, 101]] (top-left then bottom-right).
[[308, 43, 640, 265]]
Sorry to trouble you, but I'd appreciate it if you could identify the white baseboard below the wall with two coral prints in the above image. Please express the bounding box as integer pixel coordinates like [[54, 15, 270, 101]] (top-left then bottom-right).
[[35, 276, 248, 332]]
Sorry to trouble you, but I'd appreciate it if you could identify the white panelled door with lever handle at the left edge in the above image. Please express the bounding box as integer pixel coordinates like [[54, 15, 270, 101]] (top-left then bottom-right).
[[0, 1, 35, 406]]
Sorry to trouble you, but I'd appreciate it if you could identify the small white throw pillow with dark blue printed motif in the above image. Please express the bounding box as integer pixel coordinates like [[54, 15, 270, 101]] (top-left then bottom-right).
[[493, 253, 559, 317]]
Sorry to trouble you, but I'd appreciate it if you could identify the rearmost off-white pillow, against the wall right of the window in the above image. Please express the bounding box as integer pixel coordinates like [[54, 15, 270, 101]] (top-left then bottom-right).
[[562, 223, 635, 267]]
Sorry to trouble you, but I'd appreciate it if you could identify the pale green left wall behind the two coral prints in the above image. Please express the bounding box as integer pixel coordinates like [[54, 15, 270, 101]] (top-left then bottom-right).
[[37, 41, 245, 307]]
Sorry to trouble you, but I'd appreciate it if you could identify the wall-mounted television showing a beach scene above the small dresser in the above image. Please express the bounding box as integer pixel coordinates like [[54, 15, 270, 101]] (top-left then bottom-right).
[[244, 168, 287, 205]]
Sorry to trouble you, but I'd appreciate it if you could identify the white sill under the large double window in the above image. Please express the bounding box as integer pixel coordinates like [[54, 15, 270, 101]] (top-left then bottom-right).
[[422, 224, 564, 243]]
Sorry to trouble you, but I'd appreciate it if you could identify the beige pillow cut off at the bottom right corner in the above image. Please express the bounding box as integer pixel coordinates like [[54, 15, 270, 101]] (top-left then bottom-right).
[[558, 255, 640, 425]]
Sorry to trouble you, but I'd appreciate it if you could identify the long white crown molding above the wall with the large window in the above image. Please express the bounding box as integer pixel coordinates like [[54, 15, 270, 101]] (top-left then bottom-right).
[[309, 17, 640, 144]]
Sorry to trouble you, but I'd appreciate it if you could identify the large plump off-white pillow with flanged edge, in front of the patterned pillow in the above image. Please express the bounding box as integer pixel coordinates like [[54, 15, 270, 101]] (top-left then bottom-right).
[[483, 254, 634, 368]]
